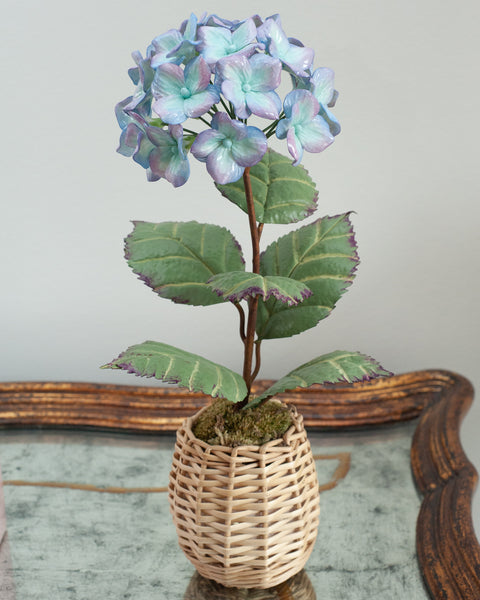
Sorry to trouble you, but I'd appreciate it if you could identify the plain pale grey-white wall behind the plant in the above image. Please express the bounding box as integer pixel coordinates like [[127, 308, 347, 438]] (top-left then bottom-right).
[[0, 0, 480, 531]]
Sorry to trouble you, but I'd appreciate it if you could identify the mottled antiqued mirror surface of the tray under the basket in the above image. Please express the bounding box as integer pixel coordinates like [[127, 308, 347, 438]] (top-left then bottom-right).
[[0, 421, 429, 600]]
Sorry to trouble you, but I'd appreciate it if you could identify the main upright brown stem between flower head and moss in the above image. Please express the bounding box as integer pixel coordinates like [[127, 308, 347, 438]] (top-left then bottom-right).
[[243, 167, 261, 394]]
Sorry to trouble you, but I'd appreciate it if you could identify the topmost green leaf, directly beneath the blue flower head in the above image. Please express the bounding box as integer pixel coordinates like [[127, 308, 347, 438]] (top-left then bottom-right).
[[215, 149, 318, 223]]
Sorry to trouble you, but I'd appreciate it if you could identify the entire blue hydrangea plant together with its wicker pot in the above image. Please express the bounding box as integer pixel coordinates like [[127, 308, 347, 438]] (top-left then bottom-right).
[[105, 15, 390, 588]]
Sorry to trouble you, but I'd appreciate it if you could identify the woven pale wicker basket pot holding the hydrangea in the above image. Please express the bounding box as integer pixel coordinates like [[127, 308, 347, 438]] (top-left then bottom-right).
[[169, 409, 320, 588]]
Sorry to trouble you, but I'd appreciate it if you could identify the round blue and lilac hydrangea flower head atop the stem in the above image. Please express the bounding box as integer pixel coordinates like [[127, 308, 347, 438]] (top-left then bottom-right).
[[116, 15, 340, 187]]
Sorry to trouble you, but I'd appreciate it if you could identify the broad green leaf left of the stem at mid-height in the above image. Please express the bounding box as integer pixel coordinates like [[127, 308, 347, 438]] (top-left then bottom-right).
[[125, 221, 245, 306]]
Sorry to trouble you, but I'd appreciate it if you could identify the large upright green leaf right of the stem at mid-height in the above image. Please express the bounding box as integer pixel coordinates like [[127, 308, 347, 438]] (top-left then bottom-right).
[[257, 214, 359, 339]]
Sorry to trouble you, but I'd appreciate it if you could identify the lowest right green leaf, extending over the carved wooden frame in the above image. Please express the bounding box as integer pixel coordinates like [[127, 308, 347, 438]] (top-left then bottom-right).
[[253, 350, 392, 406]]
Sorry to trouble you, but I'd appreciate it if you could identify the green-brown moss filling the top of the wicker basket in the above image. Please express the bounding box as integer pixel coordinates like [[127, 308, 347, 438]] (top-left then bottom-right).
[[193, 399, 292, 447]]
